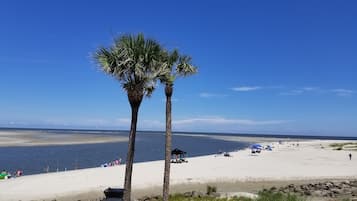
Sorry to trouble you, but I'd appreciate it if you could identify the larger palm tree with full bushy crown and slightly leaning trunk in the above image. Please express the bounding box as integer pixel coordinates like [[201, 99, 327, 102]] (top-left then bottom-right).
[[94, 34, 168, 201]]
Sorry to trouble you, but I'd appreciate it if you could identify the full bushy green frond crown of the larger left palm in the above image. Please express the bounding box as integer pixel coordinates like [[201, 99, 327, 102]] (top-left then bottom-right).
[[94, 34, 167, 101]]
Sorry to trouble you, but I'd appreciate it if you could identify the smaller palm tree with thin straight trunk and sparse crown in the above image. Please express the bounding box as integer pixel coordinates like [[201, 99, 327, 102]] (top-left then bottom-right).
[[160, 50, 197, 201]]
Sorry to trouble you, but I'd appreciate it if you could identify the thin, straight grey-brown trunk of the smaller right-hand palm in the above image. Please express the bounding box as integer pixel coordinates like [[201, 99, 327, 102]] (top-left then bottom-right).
[[162, 84, 173, 201]]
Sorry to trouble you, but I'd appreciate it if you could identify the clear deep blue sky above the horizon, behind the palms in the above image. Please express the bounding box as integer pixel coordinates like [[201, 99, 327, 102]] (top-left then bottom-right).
[[0, 0, 357, 136]]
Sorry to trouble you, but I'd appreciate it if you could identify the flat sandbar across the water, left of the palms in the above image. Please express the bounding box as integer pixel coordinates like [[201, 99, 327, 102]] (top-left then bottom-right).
[[0, 131, 128, 147]]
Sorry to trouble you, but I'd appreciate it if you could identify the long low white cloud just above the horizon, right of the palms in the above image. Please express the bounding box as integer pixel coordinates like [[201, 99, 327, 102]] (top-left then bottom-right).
[[172, 117, 289, 126]]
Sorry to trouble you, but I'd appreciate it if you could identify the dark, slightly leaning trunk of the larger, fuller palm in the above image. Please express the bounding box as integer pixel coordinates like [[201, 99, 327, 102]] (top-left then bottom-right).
[[124, 92, 143, 201]]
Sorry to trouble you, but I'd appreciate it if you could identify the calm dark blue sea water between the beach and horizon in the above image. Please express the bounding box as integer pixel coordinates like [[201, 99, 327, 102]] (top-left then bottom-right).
[[0, 129, 356, 175]]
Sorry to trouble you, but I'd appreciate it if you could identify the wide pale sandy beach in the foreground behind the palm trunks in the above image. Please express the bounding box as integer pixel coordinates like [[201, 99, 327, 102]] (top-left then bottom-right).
[[0, 140, 357, 201]]
